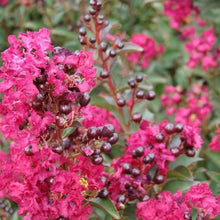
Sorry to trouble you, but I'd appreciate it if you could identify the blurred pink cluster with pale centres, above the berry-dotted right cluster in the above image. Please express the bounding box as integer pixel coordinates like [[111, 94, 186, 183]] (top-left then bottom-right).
[[161, 83, 212, 127]]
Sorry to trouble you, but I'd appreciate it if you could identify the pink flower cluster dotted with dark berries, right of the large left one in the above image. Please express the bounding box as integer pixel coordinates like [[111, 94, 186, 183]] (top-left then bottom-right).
[[108, 121, 202, 207]]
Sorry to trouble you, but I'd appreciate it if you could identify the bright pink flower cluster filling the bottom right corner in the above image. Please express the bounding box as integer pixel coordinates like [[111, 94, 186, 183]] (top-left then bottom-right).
[[136, 183, 220, 220]]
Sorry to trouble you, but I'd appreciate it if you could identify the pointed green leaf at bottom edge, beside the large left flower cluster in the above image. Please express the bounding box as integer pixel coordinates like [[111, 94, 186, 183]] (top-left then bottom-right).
[[89, 198, 120, 219]]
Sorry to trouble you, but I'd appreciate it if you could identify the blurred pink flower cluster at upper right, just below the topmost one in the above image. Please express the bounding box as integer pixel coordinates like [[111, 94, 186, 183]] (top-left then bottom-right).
[[185, 28, 217, 71]]
